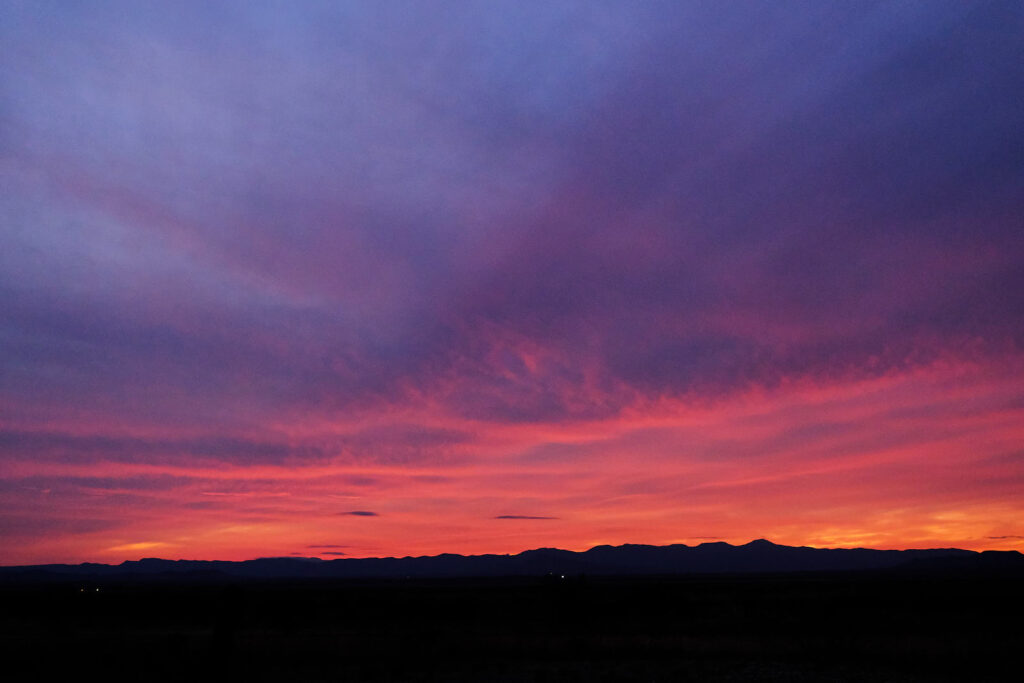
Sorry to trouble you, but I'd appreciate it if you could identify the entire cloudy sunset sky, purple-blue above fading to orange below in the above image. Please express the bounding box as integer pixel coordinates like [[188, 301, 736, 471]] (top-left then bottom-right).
[[0, 0, 1024, 564]]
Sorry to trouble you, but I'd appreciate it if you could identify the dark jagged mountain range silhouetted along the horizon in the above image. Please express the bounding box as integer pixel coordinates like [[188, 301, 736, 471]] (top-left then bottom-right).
[[0, 539, 1024, 581]]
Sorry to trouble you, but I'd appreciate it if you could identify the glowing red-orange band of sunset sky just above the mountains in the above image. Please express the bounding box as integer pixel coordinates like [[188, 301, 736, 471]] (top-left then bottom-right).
[[3, 352, 1024, 564]]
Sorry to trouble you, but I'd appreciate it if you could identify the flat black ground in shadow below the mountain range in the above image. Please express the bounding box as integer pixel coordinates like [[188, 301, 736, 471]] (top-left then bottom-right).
[[0, 574, 1024, 682]]
